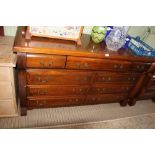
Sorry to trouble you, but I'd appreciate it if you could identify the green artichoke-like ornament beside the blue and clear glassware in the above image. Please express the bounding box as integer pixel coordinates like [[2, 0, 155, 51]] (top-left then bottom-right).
[[91, 26, 107, 43]]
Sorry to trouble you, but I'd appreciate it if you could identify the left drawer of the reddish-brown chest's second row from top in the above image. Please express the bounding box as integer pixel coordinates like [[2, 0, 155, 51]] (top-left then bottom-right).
[[27, 69, 93, 85]]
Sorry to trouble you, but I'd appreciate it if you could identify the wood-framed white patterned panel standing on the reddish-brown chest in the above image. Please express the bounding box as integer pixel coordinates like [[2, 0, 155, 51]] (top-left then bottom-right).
[[26, 26, 83, 45]]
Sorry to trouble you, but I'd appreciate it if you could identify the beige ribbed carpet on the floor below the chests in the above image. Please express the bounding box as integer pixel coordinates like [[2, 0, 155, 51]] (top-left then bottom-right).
[[0, 100, 155, 129]]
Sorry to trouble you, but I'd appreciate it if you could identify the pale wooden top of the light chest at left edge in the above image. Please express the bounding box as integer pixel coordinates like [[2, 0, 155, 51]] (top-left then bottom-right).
[[0, 36, 16, 67]]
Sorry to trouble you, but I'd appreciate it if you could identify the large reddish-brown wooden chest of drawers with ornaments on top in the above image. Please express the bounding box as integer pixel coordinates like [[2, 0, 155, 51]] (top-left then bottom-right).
[[14, 29, 155, 115]]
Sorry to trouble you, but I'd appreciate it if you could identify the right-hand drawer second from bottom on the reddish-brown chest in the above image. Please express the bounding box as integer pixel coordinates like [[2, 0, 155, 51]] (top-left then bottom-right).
[[91, 84, 133, 94]]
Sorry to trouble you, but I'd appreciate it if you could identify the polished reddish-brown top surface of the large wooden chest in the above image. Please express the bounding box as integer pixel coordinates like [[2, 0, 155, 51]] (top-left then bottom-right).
[[13, 27, 155, 63]]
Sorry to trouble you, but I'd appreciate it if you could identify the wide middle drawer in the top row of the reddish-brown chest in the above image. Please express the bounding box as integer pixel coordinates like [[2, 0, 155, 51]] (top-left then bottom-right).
[[66, 56, 131, 71]]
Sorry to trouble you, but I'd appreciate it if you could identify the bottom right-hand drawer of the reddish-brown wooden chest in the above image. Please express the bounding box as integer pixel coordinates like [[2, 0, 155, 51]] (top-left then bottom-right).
[[86, 94, 127, 104]]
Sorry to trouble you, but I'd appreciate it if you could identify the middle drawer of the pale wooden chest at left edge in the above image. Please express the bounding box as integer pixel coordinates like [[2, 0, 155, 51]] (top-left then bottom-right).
[[0, 82, 13, 100]]
